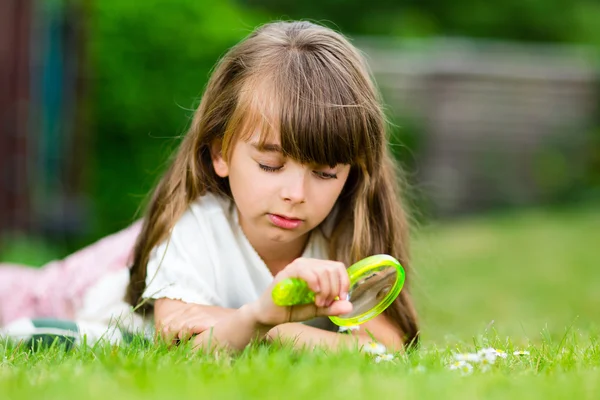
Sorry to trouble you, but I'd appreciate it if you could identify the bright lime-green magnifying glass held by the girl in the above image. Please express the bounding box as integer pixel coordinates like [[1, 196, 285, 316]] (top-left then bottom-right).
[[271, 254, 406, 326]]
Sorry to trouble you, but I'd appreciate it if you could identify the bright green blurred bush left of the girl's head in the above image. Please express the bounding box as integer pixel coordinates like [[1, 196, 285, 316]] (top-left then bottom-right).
[[84, 0, 261, 247]]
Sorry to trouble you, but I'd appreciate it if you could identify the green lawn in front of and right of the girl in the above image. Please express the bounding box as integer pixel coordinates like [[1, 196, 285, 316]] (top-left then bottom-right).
[[0, 205, 600, 400]]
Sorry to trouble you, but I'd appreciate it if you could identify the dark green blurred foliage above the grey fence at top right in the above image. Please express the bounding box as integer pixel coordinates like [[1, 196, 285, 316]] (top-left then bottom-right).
[[238, 0, 600, 45]]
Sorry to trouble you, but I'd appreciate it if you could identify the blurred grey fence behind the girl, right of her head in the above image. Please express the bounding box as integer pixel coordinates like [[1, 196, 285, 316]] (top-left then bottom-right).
[[357, 38, 598, 215]]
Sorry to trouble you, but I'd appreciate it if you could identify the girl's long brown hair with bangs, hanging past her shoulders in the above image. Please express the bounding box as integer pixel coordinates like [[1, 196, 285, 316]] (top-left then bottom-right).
[[127, 21, 419, 344]]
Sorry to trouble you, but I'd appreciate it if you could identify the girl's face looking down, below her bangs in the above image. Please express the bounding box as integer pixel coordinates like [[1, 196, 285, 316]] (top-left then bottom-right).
[[213, 134, 350, 244]]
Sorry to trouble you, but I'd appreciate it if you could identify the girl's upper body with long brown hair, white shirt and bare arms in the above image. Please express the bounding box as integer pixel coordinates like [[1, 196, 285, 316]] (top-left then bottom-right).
[[0, 22, 418, 349]]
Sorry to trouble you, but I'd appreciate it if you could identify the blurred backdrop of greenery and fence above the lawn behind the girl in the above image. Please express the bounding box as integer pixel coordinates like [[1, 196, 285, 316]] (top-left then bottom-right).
[[0, 0, 600, 253]]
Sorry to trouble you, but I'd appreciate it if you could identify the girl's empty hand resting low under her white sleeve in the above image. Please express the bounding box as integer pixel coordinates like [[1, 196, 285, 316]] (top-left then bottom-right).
[[154, 299, 235, 344]]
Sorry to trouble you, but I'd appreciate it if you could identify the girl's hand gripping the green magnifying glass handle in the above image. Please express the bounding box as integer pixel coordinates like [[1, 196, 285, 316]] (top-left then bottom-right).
[[250, 258, 352, 326]]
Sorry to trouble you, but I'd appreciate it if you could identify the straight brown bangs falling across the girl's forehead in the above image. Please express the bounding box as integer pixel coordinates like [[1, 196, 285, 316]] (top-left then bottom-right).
[[230, 55, 378, 167]]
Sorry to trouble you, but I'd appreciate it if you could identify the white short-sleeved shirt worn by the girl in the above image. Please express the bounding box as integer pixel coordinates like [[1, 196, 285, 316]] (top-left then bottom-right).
[[142, 193, 336, 326]]
